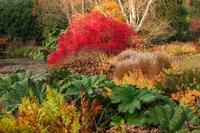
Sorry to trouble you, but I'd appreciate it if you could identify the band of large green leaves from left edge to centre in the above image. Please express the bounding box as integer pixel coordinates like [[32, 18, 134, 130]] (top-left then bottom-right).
[[0, 69, 113, 111]]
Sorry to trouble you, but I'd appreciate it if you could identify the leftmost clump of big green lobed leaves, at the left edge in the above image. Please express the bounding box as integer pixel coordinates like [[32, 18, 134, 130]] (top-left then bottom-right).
[[0, 71, 46, 111]]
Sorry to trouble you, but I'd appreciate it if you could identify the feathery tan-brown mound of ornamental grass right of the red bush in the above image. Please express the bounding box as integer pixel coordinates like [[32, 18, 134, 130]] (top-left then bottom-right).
[[114, 50, 171, 79]]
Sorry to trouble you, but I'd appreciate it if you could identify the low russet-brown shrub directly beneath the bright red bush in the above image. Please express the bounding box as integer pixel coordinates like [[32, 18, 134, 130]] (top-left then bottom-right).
[[49, 51, 112, 77]]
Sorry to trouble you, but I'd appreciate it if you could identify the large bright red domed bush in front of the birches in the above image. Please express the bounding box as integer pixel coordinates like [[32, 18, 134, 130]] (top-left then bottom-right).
[[48, 13, 137, 64]]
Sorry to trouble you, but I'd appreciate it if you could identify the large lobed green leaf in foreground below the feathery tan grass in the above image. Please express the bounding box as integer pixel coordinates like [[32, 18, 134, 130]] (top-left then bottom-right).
[[110, 85, 158, 114]]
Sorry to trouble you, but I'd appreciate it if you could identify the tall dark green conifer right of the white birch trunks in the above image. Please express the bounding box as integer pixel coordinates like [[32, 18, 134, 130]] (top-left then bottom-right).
[[156, 0, 190, 41]]
